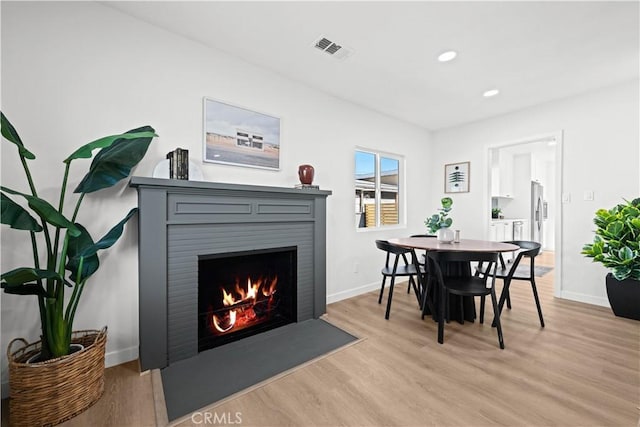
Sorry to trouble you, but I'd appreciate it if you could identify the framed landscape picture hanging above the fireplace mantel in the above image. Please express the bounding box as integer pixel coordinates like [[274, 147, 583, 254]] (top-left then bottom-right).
[[203, 97, 280, 170]]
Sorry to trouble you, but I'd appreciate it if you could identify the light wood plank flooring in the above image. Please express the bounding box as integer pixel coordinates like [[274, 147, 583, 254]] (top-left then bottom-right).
[[3, 254, 640, 426]]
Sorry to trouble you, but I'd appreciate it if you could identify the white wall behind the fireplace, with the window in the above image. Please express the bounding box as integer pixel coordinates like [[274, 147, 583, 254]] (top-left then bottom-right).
[[0, 2, 431, 392]]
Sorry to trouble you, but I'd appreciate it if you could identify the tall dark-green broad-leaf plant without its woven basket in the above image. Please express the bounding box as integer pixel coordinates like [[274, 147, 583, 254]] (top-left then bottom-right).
[[0, 112, 156, 360]]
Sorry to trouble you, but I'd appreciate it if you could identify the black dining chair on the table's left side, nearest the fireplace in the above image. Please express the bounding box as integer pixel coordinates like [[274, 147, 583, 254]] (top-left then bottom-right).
[[376, 240, 424, 319]]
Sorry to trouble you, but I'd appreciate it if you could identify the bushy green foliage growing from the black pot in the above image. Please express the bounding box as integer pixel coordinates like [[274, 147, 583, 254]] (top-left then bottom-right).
[[582, 198, 640, 280]]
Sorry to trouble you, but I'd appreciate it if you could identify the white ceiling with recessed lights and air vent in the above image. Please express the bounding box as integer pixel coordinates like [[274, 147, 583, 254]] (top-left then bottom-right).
[[104, 1, 640, 130]]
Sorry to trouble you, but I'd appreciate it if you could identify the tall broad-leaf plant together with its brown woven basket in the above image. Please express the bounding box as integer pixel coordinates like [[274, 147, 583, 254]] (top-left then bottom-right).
[[0, 112, 156, 426]]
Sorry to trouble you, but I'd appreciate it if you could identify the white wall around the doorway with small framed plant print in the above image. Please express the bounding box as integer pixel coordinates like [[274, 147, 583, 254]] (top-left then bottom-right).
[[432, 80, 640, 305]]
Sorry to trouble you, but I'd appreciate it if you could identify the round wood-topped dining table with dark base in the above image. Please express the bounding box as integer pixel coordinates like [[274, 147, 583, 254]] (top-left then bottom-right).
[[388, 237, 520, 323]]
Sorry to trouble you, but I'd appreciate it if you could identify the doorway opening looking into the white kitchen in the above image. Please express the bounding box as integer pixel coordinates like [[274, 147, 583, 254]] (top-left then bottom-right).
[[487, 131, 562, 297]]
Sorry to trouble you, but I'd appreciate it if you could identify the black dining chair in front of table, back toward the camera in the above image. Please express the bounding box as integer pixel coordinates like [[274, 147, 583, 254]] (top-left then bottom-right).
[[427, 251, 504, 349]]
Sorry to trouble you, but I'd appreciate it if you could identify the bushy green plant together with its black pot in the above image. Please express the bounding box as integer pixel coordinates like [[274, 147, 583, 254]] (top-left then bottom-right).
[[582, 198, 640, 320]]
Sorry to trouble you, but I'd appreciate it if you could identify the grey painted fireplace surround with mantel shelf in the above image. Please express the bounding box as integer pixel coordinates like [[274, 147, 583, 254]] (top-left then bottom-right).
[[130, 177, 331, 370]]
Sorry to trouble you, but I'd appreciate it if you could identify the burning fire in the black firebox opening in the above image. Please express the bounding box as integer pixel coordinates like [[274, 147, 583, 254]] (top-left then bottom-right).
[[198, 247, 297, 352]]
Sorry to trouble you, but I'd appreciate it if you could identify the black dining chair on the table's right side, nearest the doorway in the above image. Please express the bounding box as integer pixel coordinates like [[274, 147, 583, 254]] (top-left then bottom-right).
[[476, 240, 544, 328]]
